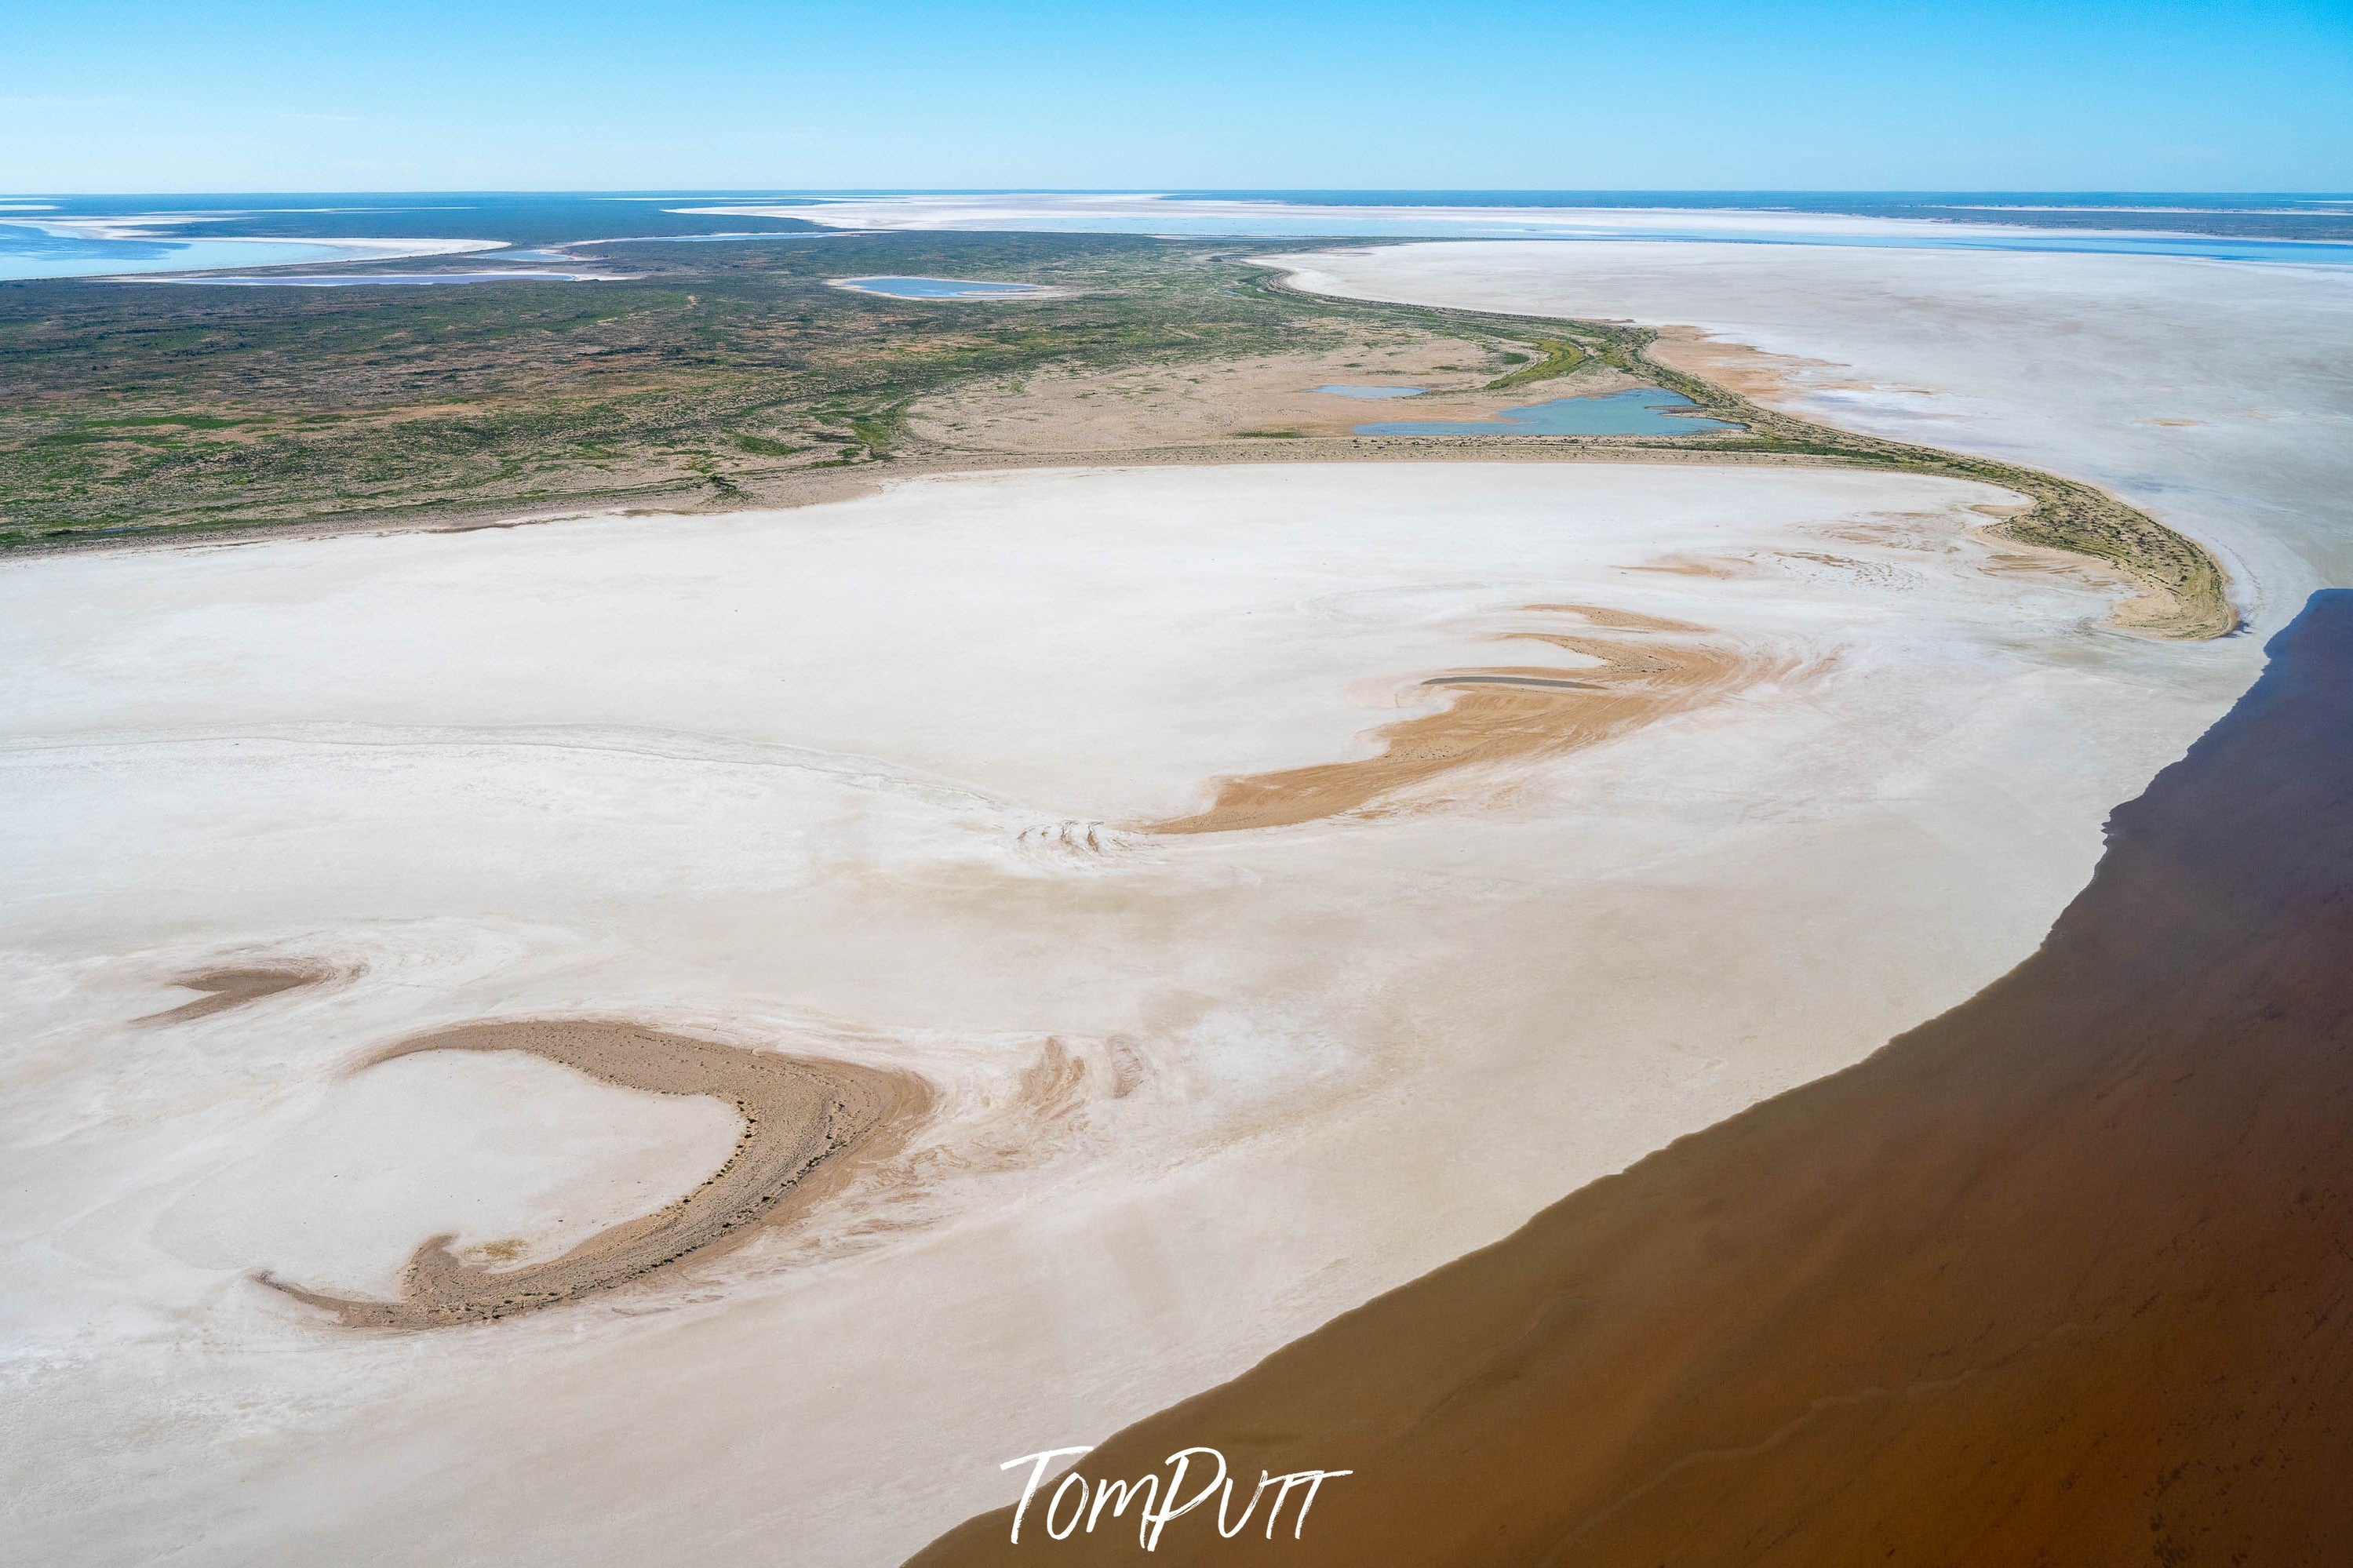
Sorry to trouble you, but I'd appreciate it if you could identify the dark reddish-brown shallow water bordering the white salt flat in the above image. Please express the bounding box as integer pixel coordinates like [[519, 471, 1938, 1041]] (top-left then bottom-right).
[[916, 592, 2353, 1568]]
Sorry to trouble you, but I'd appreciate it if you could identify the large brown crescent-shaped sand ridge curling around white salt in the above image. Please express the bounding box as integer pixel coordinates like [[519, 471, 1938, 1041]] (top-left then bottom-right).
[[261, 1020, 932, 1328]]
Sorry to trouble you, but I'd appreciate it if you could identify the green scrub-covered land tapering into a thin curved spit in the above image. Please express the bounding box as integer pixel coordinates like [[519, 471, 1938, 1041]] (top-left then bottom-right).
[[0, 225, 2235, 635]]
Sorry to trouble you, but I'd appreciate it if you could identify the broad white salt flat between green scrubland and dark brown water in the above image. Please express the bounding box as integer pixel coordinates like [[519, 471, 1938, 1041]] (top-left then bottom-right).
[[0, 247, 2344, 1563]]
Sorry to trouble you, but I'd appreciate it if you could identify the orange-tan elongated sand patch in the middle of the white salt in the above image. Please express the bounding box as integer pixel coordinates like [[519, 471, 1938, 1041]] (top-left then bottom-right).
[[1146, 604, 1790, 835]]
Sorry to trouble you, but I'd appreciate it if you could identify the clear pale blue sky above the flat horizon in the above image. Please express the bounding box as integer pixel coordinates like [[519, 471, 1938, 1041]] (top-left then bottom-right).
[[13, 0, 2353, 193]]
